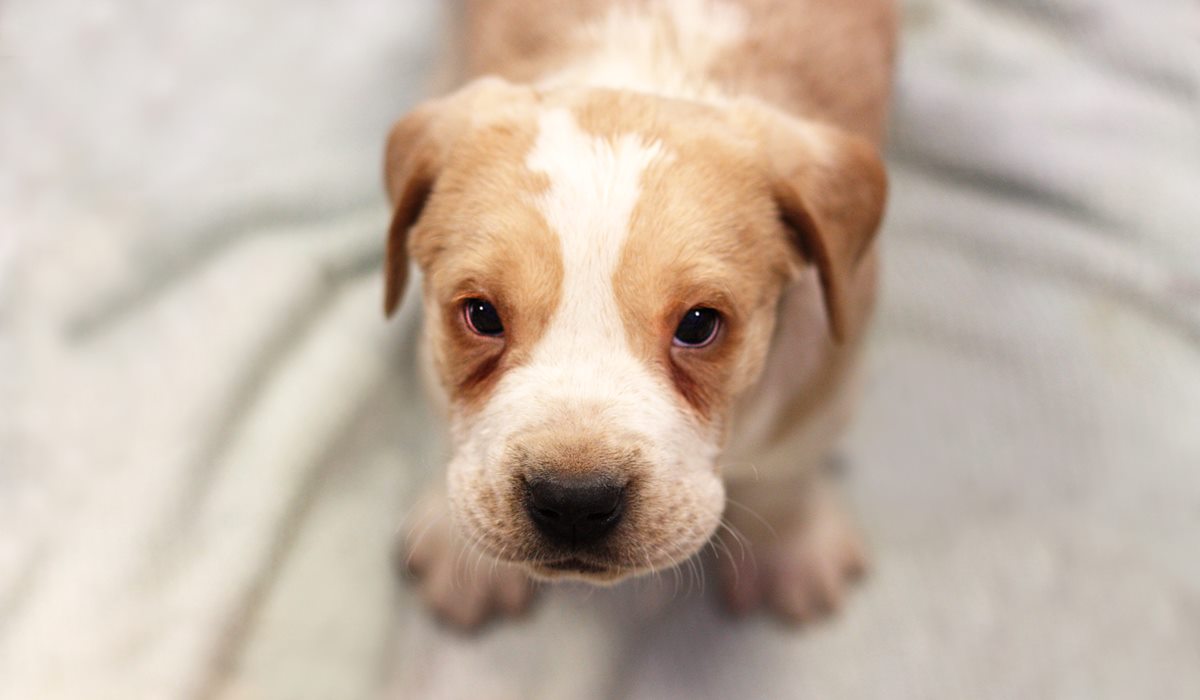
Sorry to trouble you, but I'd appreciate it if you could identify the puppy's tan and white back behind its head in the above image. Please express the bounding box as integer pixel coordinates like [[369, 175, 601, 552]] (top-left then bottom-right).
[[464, 0, 895, 142]]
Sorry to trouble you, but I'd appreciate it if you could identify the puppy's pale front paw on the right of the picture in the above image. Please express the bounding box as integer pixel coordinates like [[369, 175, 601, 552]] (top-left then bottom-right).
[[720, 487, 866, 623]]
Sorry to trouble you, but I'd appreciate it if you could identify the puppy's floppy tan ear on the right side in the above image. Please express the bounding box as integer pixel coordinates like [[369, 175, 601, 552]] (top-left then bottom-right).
[[734, 104, 887, 342]]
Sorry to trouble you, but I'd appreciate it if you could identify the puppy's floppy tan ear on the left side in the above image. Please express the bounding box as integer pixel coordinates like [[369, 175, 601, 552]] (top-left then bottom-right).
[[383, 76, 518, 317]]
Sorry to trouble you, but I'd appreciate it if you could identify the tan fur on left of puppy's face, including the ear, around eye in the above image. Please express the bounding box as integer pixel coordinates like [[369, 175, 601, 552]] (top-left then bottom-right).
[[386, 85, 563, 408]]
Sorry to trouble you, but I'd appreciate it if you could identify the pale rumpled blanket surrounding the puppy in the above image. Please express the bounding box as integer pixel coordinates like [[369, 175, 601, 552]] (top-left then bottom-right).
[[0, 0, 1200, 700]]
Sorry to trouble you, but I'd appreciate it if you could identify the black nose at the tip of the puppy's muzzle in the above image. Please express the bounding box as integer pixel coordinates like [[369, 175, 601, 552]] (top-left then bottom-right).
[[526, 477, 625, 545]]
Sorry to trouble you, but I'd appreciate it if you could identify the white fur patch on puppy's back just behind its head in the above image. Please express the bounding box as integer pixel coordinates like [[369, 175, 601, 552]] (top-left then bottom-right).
[[535, 0, 746, 102]]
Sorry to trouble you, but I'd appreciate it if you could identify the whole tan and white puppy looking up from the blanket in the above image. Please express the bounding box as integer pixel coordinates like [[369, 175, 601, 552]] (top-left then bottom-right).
[[384, 0, 896, 627]]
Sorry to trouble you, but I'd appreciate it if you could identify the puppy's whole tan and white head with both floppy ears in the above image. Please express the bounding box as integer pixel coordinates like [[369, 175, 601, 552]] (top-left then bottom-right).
[[386, 79, 883, 581]]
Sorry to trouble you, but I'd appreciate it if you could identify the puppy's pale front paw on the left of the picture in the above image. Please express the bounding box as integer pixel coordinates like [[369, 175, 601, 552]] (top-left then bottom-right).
[[397, 503, 533, 629]]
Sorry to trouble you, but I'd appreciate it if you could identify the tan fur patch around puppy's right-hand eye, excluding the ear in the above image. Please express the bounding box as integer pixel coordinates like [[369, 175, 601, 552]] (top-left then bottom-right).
[[592, 97, 794, 419]]
